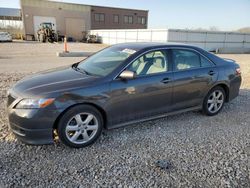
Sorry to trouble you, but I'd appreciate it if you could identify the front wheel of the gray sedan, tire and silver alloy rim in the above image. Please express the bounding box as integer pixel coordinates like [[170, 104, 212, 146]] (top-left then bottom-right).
[[57, 105, 103, 148]]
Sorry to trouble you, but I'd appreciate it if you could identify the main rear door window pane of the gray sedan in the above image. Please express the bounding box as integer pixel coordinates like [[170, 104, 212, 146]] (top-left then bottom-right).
[[173, 50, 201, 70]]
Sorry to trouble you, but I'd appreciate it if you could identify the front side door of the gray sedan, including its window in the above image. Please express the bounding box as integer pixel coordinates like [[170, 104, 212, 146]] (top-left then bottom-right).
[[108, 50, 173, 125]]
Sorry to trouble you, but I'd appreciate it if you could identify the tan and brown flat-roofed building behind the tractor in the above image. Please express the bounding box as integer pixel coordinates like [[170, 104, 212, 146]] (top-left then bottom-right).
[[20, 0, 148, 40]]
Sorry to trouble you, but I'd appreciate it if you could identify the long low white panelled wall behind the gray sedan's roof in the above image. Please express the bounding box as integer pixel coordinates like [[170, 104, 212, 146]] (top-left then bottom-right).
[[91, 29, 250, 53]]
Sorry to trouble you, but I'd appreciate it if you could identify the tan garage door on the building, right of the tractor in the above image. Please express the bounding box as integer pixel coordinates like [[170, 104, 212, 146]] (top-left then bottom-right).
[[65, 18, 85, 40]]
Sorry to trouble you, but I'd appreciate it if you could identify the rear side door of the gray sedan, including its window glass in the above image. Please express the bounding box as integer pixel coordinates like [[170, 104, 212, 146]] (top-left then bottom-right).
[[171, 49, 218, 110]]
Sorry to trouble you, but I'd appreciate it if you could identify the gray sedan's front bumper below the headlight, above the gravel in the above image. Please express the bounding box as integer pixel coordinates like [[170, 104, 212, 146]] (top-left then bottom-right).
[[8, 109, 59, 145]]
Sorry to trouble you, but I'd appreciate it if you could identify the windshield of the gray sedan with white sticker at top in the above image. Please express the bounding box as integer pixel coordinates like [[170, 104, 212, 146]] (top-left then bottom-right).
[[77, 46, 136, 76]]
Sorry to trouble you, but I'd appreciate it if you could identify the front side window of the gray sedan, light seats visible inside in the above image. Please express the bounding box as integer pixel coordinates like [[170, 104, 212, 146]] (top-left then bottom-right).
[[127, 50, 168, 76]]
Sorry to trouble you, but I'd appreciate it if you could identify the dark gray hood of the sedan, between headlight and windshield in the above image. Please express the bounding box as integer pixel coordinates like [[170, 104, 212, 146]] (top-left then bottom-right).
[[12, 67, 98, 96]]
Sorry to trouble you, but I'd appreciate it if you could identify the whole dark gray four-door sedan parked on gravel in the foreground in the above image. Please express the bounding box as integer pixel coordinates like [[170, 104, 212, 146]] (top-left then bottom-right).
[[8, 43, 241, 148]]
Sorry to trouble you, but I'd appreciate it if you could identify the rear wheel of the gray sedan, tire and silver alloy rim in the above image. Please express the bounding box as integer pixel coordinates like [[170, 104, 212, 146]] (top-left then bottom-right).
[[202, 86, 226, 116]]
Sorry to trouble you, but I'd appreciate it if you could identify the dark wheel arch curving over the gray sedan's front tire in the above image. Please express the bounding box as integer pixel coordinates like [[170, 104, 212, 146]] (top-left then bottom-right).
[[53, 102, 107, 129]]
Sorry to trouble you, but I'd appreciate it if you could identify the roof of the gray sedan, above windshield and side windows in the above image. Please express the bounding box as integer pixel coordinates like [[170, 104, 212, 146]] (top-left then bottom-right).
[[111, 42, 197, 51]]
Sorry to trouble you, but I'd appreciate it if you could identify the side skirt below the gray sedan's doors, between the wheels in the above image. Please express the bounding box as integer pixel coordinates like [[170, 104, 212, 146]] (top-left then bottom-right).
[[107, 106, 202, 129]]
